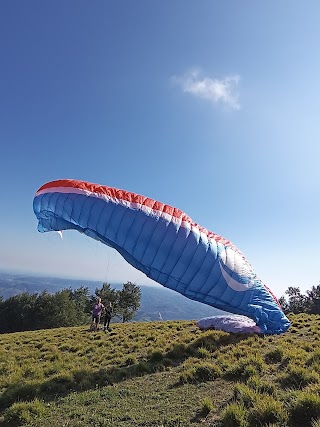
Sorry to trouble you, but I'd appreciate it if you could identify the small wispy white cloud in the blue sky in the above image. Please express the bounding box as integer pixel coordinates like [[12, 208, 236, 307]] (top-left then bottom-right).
[[172, 71, 240, 110]]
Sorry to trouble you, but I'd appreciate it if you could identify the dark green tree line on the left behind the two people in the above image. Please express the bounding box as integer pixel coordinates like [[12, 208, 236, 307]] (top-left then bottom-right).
[[0, 282, 141, 333]]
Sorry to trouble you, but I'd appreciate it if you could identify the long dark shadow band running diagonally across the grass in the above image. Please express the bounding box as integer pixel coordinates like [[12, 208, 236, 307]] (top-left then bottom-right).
[[0, 332, 254, 412]]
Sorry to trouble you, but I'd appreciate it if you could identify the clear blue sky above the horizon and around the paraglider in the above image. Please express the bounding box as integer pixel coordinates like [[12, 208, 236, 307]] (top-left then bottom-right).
[[0, 0, 320, 296]]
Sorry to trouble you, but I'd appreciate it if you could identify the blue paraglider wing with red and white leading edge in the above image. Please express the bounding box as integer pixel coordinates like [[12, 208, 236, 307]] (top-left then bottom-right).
[[33, 180, 290, 334]]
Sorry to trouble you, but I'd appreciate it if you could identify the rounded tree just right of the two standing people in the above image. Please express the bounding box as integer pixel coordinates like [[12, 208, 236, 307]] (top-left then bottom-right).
[[117, 282, 141, 322]]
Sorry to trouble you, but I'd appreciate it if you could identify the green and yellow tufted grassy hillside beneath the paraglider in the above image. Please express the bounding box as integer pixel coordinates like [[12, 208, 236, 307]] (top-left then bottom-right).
[[0, 314, 320, 427]]
